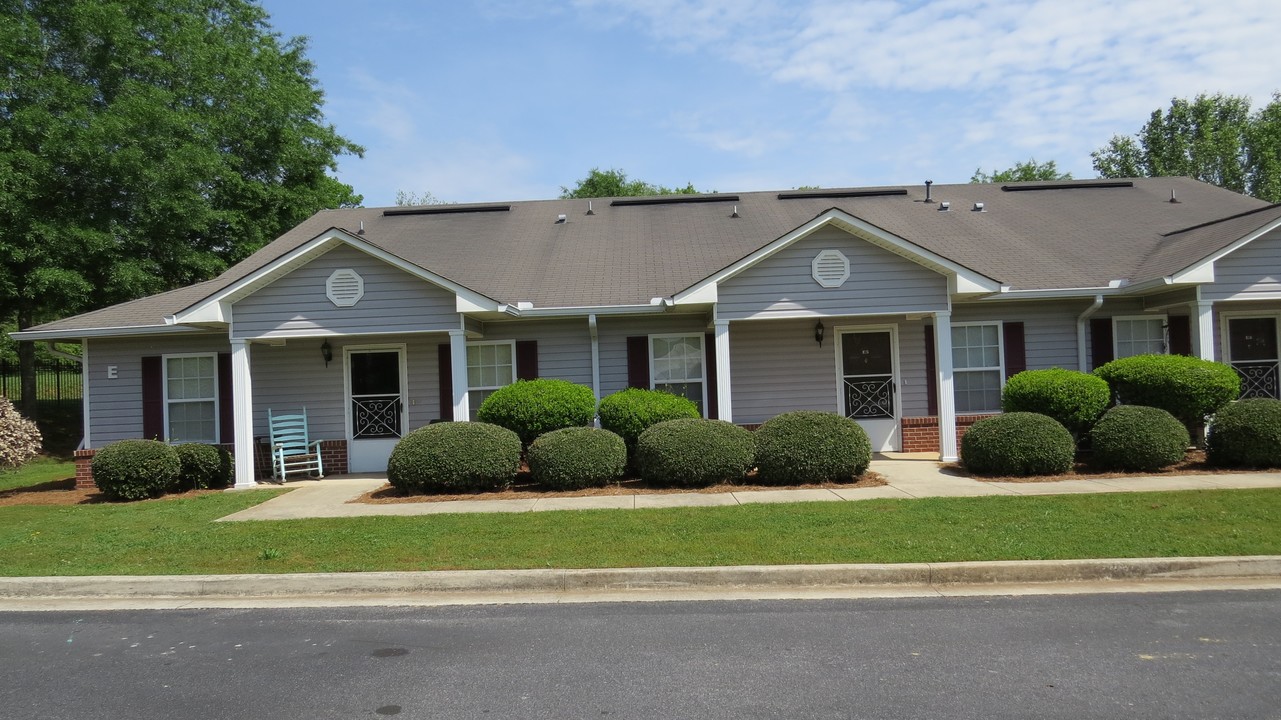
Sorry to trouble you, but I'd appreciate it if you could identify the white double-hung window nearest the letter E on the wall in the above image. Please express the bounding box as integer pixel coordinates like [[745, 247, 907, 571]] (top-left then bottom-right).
[[164, 354, 218, 443]]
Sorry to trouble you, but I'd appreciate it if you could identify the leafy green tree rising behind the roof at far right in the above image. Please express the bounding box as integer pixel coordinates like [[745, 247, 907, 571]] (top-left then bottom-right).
[[1090, 94, 1281, 202]]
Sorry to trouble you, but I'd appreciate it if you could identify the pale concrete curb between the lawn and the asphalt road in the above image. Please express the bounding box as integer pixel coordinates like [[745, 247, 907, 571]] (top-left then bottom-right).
[[0, 555, 1281, 600]]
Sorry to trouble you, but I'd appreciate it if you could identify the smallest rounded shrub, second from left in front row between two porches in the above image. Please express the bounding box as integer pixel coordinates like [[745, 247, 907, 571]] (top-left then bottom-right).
[[528, 428, 628, 489]]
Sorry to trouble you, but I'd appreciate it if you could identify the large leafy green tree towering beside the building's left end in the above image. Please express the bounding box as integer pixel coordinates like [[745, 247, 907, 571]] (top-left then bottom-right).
[[0, 0, 364, 414]]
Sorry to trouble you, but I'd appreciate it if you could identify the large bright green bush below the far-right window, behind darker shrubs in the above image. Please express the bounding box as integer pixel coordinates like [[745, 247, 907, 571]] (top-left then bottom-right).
[[1094, 355, 1241, 428]]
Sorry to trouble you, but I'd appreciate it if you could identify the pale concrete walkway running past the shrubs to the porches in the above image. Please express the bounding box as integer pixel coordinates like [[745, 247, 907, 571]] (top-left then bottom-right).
[[220, 454, 1281, 521]]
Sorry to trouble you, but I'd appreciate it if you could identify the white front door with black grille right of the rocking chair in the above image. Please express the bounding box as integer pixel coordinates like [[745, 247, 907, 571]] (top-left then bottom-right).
[[345, 347, 409, 473]]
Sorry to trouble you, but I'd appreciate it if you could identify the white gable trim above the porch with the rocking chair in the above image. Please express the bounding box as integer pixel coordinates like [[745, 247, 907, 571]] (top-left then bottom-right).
[[165, 228, 498, 324]]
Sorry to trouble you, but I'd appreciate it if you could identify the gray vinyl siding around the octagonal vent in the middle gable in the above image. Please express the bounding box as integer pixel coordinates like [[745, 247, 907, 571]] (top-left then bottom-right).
[[717, 228, 948, 319]]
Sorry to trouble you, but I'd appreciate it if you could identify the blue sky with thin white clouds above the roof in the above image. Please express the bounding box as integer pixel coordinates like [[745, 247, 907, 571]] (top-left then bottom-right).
[[263, 0, 1281, 206]]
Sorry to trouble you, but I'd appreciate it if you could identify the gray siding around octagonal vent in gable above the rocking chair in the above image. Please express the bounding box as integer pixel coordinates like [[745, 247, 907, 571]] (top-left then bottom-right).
[[232, 246, 461, 337]]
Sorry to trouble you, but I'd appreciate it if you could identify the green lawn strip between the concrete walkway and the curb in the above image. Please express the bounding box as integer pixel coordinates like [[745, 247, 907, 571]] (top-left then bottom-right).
[[0, 489, 1281, 575]]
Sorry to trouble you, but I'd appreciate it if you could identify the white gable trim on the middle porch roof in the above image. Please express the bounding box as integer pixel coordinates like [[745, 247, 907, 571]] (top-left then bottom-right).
[[673, 209, 1000, 305]]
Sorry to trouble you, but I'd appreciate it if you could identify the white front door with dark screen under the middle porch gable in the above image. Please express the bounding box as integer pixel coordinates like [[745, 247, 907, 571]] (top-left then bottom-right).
[[836, 328, 899, 451]]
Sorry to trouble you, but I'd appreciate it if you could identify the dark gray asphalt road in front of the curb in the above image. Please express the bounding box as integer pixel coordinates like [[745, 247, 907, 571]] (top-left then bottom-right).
[[0, 591, 1281, 720]]
